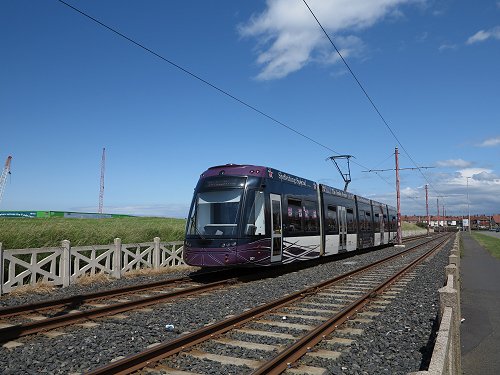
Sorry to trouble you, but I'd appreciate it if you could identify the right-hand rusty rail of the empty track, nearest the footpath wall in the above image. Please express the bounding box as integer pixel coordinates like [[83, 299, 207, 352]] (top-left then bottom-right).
[[252, 234, 449, 375]]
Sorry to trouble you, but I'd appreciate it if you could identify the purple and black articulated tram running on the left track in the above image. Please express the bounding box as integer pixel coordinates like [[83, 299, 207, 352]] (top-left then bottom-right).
[[183, 164, 397, 267]]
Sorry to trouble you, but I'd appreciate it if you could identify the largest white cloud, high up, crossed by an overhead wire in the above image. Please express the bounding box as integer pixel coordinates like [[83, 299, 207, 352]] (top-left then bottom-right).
[[239, 0, 416, 80]]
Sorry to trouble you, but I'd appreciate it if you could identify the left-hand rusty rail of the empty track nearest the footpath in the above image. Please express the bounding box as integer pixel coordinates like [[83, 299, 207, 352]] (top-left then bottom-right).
[[88, 234, 450, 375]]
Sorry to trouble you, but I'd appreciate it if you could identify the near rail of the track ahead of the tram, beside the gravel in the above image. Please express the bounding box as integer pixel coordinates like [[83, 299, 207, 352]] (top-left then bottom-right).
[[0, 279, 236, 342]]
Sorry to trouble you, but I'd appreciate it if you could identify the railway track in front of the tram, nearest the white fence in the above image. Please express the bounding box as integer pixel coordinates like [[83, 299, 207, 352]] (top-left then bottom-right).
[[0, 271, 249, 342]]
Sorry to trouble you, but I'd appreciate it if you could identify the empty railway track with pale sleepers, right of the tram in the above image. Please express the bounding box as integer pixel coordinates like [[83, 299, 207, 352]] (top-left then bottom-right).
[[87, 236, 450, 375]]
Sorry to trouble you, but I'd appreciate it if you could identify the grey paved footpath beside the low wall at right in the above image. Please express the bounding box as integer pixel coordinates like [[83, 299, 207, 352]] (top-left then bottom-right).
[[460, 232, 500, 375]]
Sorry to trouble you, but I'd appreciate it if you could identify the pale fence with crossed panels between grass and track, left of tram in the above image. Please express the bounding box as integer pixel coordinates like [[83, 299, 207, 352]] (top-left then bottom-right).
[[0, 237, 185, 295]]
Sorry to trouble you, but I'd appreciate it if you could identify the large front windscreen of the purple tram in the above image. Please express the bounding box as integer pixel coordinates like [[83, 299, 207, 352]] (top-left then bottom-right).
[[188, 189, 243, 237]]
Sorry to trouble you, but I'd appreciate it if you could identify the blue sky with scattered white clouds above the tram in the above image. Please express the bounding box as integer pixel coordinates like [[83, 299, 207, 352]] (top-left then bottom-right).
[[0, 0, 500, 217]]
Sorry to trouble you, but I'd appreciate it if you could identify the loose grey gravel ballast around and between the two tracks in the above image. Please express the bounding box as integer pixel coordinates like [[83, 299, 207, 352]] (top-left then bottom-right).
[[0, 238, 452, 374]]
